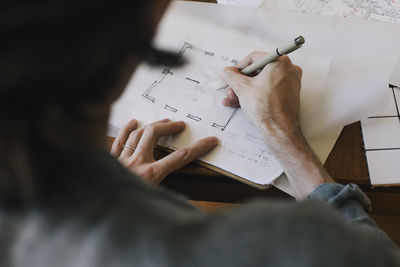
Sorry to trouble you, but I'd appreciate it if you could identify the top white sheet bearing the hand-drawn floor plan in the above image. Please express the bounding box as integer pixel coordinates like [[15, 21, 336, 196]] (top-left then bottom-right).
[[110, 10, 330, 184]]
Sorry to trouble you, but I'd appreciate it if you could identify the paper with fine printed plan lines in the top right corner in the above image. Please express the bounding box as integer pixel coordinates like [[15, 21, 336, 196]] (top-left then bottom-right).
[[280, 0, 400, 23]]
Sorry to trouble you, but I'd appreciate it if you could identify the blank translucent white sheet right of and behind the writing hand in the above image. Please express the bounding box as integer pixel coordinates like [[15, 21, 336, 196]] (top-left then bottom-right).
[[179, 3, 400, 136]]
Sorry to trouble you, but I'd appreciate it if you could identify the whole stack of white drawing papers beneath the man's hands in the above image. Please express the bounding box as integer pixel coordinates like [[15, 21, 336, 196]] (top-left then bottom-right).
[[110, 2, 400, 192]]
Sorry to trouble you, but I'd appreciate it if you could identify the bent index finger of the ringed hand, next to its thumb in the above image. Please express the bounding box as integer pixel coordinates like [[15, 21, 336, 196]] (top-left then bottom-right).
[[135, 121, 185, 158]]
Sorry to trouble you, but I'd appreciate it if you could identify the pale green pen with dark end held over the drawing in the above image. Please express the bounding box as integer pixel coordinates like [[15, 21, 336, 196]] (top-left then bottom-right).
[[220, 36, 305, 89]]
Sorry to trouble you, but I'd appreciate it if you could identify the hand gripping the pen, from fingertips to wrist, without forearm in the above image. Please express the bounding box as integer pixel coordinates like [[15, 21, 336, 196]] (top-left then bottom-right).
[[222, 52, 302, 141]]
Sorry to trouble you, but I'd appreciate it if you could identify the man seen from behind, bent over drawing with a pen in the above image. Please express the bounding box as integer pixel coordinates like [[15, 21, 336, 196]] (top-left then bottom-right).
[[0, 0, 400, 267]]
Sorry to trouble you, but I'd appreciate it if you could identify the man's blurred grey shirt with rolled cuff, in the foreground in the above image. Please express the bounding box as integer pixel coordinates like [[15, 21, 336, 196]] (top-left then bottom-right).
[[0, 151, 400, 267]]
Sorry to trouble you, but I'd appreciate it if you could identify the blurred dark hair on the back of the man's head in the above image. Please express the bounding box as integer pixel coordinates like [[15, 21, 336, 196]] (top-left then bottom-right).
[[0, 0, 176, 207]]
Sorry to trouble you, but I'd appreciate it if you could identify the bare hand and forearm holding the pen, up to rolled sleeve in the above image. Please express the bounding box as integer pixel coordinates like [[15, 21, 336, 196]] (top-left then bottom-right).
[[222, 52, 334, 200]]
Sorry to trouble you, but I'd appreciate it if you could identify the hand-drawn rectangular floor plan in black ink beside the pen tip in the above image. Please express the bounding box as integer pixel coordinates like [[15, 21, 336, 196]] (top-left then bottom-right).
[[142, 42, 238, 131]]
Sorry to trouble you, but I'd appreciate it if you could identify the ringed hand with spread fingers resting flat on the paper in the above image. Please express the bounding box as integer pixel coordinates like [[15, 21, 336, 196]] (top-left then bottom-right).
[[111, 119, 218, 185]]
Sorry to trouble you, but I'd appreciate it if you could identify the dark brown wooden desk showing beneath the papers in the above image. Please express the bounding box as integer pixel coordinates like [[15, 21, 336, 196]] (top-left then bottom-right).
[[109, 0, 400, 246]]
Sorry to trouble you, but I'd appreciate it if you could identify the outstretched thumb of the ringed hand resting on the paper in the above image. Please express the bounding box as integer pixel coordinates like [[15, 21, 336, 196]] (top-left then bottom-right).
[[154, 137, 218, 176]]
